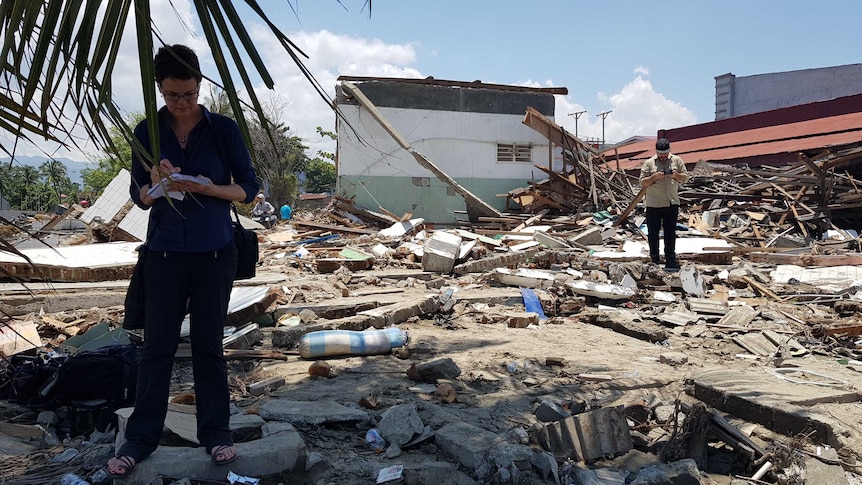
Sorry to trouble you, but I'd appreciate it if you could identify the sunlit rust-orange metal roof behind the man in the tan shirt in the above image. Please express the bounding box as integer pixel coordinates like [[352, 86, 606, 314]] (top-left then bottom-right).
[[604, 113, 862, 171]]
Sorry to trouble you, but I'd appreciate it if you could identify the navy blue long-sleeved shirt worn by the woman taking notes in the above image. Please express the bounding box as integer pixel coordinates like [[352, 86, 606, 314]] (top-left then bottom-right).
[[129, 106, 260, 253]]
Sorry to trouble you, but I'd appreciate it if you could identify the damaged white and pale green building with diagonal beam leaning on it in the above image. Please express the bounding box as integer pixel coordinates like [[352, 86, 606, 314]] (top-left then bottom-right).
[[335, 76, 568, 223]]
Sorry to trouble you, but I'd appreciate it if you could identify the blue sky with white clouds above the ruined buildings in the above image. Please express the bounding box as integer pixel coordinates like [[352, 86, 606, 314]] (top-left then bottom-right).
[[11, 0, 862, 160]]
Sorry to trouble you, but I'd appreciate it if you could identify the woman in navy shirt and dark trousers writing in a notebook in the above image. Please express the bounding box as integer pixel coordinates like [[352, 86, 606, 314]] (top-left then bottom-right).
[[108, 45, 259, 477]]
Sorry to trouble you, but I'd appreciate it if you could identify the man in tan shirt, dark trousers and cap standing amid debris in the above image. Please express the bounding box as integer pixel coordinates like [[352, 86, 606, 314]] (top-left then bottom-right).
[[640, 138, 688, 269]]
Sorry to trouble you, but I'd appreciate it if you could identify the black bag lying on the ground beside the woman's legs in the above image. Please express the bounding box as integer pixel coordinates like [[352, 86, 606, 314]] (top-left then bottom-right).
[[26, 344, 140, 409]]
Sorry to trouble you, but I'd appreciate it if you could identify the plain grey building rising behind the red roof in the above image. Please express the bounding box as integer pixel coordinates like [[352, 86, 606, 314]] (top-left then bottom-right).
[[715, 64, 862, 120]]
